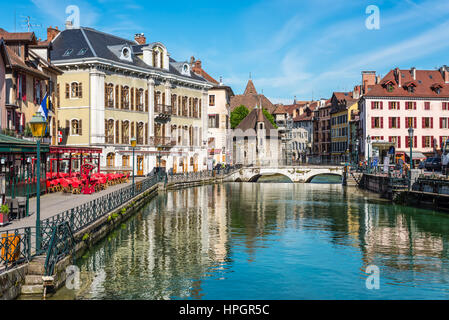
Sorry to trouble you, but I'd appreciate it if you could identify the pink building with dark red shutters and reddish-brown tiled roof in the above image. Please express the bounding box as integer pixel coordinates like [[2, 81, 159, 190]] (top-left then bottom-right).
[[359, 66, 449, 159]]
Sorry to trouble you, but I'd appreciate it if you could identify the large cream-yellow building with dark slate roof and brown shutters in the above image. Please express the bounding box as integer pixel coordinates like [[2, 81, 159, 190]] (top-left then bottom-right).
[[51, 27, 212, 175]]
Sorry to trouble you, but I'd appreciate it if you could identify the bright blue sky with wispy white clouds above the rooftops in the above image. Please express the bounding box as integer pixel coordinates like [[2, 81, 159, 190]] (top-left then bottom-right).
[[0, 0, 449, 103]]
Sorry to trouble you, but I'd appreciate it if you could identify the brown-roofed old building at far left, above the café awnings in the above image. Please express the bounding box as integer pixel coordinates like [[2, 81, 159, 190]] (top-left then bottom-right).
[[0, 29, 62, 144]]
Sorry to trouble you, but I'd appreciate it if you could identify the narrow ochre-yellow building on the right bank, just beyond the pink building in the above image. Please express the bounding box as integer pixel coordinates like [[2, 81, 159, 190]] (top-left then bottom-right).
[[331, 92, 358, 163]]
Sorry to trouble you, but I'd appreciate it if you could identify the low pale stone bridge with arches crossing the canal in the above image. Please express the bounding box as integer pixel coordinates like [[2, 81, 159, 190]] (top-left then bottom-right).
[[225, 166, 343, 183]]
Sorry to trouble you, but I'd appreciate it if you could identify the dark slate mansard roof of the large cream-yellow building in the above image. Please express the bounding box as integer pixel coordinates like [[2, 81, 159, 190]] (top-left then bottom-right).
[[50, 27, 208, 83]]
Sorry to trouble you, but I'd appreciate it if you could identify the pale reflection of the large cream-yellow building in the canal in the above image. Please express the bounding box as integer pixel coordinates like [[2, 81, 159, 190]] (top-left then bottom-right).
[[78, 185, 228, 299]]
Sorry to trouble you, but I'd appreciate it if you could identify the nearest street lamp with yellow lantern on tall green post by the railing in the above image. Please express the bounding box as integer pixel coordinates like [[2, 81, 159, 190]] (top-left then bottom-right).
[[30, 112, 47, 252]]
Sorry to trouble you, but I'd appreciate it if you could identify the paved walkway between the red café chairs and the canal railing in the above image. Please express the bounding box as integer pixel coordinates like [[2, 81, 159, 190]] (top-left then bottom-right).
[[0, 177, 144, 232]]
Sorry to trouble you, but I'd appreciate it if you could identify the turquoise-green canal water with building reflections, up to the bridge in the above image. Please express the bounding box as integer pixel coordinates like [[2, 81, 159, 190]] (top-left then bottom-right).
[[54, 183, 449, 299]]
